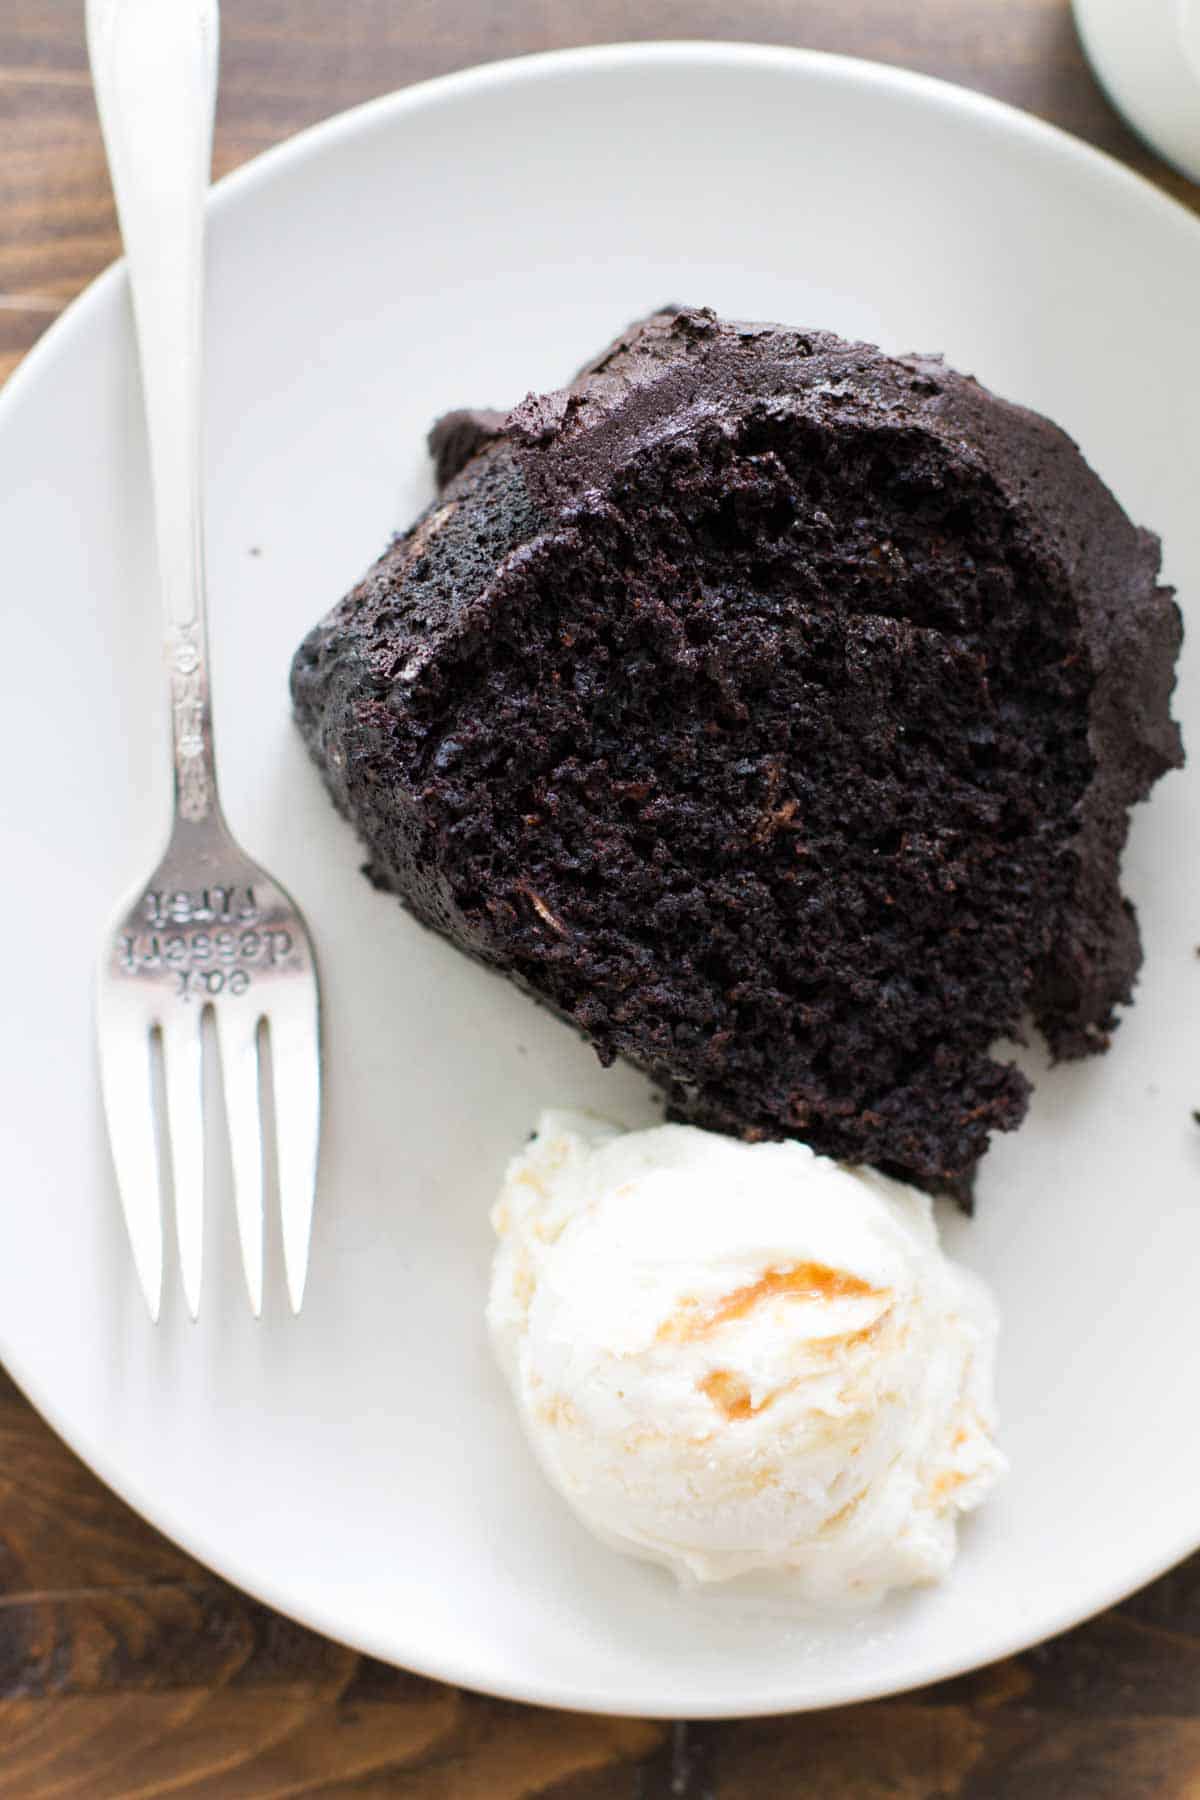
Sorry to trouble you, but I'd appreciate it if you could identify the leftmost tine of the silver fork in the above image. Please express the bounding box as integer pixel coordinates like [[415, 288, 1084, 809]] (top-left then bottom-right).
[[101, 1019, 162, 1325]]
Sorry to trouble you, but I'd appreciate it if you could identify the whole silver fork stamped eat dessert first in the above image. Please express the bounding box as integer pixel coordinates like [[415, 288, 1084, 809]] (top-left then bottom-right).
[[88, 0, 320, 1319]]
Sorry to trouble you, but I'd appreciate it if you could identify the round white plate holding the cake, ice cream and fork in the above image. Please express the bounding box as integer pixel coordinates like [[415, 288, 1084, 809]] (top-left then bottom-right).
[[0, 35, 1200, 1715]]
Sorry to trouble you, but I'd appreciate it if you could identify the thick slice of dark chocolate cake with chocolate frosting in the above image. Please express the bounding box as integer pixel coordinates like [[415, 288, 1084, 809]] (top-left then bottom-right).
[[291, 310, 1182, 1195]]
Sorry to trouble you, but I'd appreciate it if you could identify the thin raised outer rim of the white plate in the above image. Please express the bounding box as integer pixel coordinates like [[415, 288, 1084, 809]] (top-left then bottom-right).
[[0, 38, 1200, 1719]]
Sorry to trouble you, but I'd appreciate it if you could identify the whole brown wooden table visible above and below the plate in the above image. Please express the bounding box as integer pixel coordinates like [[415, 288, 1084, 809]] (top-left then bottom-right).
[[0, 0, 1200, 1800]]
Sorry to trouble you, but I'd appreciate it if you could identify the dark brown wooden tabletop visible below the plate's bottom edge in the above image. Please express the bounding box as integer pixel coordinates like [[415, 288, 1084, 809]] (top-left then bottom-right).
[[11, 1375, 1200, 1800]]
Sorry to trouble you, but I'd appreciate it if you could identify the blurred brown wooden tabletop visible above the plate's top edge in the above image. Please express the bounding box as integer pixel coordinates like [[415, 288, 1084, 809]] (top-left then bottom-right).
[[0, 0, 1200, 378]]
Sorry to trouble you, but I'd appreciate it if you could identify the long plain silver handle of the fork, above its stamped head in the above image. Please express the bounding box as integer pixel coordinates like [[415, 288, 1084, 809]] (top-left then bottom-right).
[[86, 0, 218, 823]]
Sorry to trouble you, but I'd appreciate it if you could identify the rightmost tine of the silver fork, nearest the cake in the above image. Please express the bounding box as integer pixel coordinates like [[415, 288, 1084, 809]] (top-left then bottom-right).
[[268, 994, 320, 1312]]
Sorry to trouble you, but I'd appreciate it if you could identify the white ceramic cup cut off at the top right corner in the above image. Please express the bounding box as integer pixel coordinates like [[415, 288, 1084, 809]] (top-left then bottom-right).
[[1074, 0, 1200, 182]]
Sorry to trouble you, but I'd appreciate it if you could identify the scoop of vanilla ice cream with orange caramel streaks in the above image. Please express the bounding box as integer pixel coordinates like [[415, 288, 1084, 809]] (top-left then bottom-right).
[[488, 1112, 1004, 1606]]
